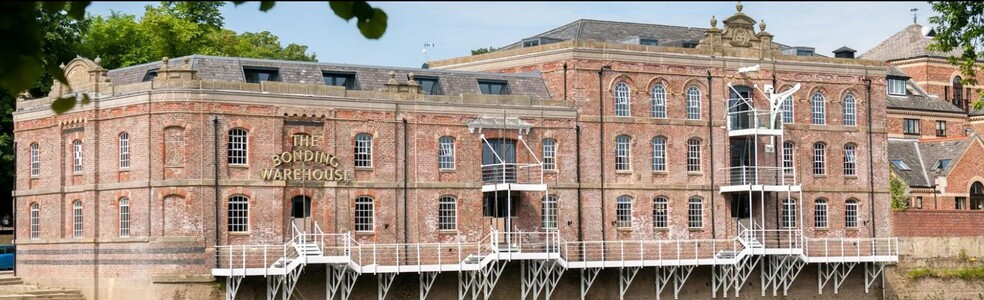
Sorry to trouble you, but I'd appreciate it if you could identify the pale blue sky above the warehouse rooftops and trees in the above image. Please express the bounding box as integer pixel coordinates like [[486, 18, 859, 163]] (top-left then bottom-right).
[[87, 1, 933, 67]]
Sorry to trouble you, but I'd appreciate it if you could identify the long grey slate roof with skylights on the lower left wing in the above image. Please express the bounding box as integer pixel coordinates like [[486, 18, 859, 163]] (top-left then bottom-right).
[[108, 55, 551, 99]]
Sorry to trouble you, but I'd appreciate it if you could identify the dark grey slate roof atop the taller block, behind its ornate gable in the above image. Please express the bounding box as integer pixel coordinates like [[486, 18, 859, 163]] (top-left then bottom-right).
[[499, 19, 790, 50]]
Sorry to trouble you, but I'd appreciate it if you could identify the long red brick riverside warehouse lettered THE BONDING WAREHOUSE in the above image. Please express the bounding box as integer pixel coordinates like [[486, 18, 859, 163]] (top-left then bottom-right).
[[15, 4, 898, 299]]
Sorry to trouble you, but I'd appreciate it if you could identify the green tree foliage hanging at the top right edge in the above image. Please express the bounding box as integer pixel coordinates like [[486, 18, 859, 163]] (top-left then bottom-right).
[[929, 1, 984, 109]]
